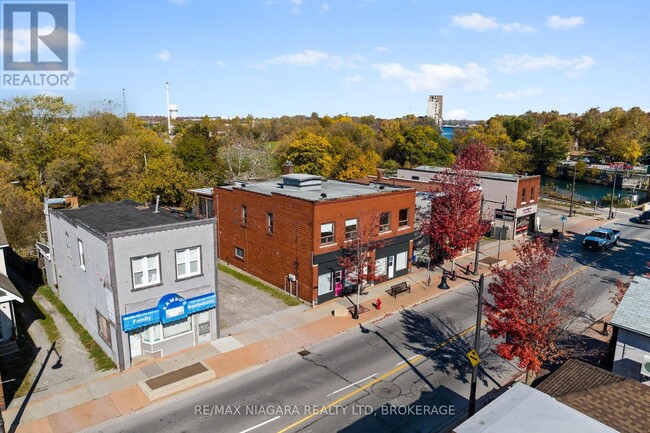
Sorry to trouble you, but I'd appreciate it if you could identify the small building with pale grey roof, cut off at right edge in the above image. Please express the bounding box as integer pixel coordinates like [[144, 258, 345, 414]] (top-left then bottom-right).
[[610, 275, 650, 384]]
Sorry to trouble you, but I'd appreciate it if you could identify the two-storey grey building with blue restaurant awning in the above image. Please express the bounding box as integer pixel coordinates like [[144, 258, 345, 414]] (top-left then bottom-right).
[[39, 201, 219, 370]]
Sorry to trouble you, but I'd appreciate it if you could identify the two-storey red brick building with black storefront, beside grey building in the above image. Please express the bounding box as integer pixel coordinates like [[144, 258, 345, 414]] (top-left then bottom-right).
[[214, 173, 415, 305]]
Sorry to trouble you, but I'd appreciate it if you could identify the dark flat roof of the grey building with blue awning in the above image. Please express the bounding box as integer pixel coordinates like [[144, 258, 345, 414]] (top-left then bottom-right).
[[50, 200, 205, 237]]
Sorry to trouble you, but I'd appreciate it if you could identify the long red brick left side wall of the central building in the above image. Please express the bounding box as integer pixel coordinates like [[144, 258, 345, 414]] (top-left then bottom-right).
[[215, 188, 314, 302]]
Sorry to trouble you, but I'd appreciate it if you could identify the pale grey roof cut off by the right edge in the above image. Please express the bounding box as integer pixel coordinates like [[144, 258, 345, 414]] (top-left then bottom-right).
[[610, 275, 650, 337]]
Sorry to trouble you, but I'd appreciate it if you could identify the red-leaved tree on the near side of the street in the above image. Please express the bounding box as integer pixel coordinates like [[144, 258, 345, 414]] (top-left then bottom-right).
[[484, 238, 582, 377]]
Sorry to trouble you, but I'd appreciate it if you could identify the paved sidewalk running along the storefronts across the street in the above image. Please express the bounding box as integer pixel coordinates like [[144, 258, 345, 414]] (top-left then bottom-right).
[[2, 209, 602, 433]]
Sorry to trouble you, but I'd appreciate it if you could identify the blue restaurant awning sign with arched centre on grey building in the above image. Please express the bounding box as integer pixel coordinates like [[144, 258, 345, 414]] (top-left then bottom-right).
[[122, 293, 217, 332]]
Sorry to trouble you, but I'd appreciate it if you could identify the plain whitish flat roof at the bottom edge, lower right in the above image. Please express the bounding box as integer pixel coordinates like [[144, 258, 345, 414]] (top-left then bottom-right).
[[454, 382, 616, 433]]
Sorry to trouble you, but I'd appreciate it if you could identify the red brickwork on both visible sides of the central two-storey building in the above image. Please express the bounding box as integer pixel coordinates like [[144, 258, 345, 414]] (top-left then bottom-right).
[[214, 188, 415, 302]]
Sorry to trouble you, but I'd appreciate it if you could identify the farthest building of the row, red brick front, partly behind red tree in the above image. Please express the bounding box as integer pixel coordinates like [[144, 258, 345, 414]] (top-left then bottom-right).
[[394, 166, 541, 240]]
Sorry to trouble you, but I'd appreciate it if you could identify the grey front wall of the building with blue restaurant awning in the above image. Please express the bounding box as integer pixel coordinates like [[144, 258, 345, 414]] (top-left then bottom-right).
[[112, 220, 219, 368]]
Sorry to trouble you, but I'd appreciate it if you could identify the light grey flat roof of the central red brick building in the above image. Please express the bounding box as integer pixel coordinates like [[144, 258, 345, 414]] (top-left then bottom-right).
[[219, 174, 413, 202]]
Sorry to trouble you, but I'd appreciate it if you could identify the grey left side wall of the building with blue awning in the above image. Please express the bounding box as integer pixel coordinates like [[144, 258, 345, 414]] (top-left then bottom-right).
[[46, 210, 119, 364]]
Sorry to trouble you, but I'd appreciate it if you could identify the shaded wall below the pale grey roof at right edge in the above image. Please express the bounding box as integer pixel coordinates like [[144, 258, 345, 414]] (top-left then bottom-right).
[[612, 328, 650, 380]]
